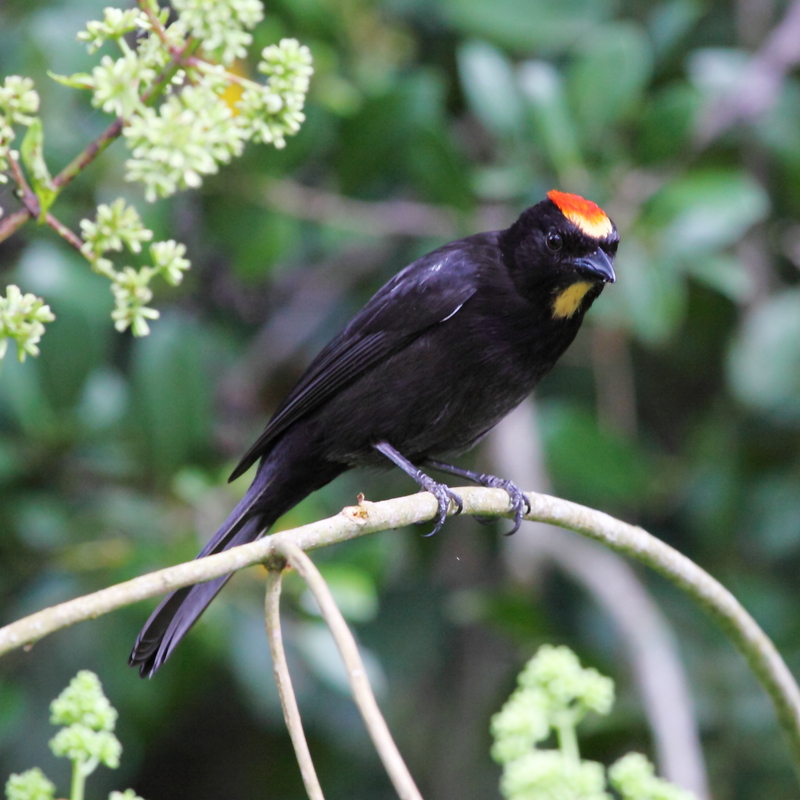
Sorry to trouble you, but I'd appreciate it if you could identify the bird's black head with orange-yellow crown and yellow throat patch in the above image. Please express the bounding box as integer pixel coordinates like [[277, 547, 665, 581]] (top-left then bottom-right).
[[501, 189, 619, 319]]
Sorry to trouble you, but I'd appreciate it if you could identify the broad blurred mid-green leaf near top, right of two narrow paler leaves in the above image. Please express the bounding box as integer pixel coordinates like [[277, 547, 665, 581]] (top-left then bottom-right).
[[567, 22, 653, 141]]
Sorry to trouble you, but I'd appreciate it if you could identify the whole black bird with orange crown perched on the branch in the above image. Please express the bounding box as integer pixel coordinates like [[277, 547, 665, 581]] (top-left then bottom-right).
[[130, 191, 619, 677]]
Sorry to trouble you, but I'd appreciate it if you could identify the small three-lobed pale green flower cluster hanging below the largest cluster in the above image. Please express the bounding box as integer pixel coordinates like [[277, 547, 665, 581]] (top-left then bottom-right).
[[81, 203, 191, 336]]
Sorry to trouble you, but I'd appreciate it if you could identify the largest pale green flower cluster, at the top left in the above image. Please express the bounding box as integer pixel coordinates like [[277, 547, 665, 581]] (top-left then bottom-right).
[[54, 0, 313, 202]]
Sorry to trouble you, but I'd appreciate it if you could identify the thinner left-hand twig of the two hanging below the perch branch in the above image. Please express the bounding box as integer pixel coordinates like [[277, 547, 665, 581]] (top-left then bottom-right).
[[264, 569, 325, 800]]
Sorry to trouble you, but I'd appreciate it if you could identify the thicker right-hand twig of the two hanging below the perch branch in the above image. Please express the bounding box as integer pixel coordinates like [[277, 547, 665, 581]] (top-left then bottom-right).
[[278, 539, 422, 800]]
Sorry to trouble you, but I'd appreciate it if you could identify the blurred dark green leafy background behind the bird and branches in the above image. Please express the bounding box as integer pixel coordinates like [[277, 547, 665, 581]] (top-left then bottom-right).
[[0, 0, 800, 800]]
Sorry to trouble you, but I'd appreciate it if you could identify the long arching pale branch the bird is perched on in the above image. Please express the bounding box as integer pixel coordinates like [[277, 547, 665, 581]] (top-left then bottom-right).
[[0, 487, 800, 774]]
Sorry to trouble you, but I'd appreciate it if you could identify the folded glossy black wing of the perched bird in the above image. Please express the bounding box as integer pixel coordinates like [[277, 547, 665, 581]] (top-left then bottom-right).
[[229, 241, 491, 480]]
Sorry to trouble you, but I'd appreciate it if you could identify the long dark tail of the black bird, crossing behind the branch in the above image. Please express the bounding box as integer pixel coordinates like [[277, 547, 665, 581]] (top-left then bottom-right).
[[128, 444, 344, 678]]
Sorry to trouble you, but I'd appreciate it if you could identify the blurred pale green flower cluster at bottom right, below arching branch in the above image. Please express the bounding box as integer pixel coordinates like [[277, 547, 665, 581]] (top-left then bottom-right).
[[491, 645, 696, 800]]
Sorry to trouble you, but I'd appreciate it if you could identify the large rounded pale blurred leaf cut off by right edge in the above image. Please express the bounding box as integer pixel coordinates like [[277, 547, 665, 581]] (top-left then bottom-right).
[[728, 289, 800, 421]]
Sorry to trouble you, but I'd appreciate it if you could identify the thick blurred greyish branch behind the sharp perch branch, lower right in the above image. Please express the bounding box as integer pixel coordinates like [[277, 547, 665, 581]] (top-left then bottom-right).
[[489, 406, 710, 798]]
